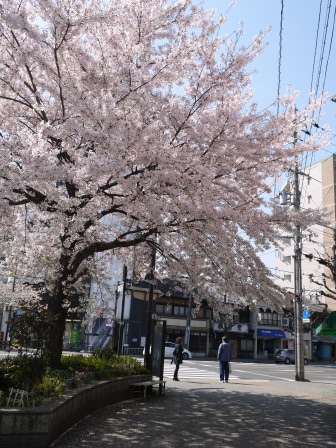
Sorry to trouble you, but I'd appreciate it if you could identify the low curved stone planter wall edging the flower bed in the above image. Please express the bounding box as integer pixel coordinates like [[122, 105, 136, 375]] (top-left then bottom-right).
[[0, 374, 152, 448]]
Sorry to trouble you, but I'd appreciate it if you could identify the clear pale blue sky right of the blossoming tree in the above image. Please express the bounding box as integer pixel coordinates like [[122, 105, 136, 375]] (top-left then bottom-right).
[[204, 0, 336, 268]]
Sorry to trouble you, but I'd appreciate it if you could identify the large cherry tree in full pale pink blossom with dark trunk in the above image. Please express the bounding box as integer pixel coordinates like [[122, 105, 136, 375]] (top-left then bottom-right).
[[0, 0, 323, 365]]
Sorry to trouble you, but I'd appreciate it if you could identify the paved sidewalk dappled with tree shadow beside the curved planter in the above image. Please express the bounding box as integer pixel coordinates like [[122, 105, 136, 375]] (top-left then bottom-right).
[[52, 374, 336, 448]]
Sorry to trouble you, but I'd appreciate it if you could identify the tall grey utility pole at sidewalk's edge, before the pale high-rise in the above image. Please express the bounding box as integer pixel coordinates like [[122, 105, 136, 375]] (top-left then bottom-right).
[[293, 161, 304, 381]]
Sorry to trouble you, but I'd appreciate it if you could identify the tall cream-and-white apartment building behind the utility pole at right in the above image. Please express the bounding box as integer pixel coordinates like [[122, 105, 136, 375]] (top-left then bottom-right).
[[274, 155, 336, 311]]
